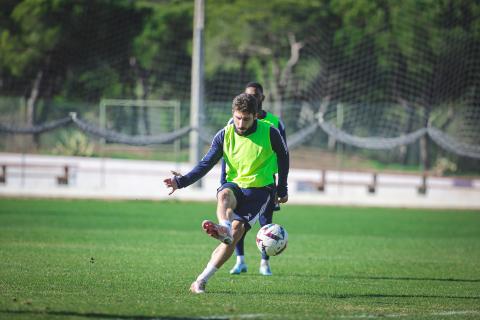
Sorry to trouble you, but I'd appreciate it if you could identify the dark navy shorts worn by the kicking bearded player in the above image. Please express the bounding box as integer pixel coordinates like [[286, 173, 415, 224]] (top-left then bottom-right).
[[217, 182, 272, 230]]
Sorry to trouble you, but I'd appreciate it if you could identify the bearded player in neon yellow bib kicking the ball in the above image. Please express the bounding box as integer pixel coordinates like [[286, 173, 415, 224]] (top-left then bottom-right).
[[164, 93, 289, 293]]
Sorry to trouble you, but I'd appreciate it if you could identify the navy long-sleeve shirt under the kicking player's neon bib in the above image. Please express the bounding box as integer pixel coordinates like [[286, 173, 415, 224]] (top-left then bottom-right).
[[175, 120, 290, 197]]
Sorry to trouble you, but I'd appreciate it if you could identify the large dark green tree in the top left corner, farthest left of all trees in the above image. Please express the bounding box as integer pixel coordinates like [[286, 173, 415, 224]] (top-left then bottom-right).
[[0, 0, 146, 142]]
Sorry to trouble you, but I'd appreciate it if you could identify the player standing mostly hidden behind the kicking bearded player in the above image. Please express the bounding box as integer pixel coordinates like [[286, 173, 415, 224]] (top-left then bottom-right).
[[226, 82, 287, 276]]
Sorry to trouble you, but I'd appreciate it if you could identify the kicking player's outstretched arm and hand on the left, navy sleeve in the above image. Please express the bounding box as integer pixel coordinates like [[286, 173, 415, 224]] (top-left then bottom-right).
[[163, 129, 225, 194]]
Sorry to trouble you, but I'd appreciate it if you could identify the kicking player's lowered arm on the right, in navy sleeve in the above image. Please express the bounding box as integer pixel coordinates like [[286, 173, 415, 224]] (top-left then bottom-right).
[[270, 127, 290, 203]]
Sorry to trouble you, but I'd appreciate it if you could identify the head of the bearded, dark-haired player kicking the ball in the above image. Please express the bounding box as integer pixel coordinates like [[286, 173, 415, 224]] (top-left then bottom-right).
[[232, 93, 257, 135]]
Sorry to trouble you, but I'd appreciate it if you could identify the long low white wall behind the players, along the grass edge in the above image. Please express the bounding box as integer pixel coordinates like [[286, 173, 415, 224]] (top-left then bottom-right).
[[0, 153, 480, 209]]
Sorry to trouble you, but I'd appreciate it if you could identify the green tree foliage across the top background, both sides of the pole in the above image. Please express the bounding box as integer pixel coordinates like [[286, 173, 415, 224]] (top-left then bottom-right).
[[0, 0, 480, 101]]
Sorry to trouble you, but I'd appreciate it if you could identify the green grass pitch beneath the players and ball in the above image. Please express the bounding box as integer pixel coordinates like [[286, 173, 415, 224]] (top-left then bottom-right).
[[0, 199, 480, 319]]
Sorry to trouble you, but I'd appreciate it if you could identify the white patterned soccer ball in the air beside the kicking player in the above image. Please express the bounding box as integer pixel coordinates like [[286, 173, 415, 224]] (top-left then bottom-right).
[[257, 223, 288, 256]]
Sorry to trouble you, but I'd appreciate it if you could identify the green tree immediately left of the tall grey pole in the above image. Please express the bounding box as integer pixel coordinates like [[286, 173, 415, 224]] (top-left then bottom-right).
[[130, 1, 193, 134]]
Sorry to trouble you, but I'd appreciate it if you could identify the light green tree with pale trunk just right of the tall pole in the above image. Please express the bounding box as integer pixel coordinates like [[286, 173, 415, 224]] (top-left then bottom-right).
[[206, 0, 332, 115]]
